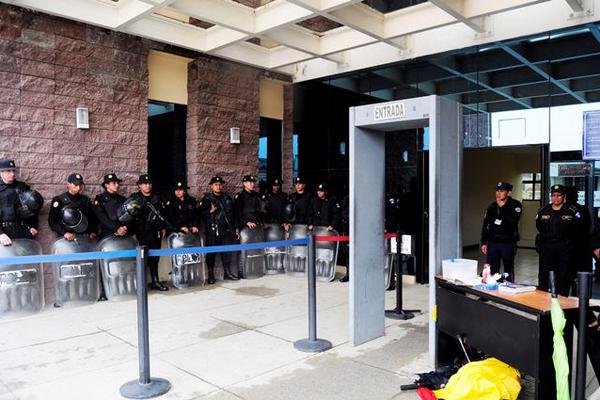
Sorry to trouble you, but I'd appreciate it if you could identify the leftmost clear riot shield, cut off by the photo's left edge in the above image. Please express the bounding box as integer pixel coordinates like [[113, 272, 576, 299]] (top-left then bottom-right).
[[0, 239, 44, 317]]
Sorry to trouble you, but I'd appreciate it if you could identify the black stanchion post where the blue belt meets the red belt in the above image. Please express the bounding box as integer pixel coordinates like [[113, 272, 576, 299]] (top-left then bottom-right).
[[294, 233, 331, 353]]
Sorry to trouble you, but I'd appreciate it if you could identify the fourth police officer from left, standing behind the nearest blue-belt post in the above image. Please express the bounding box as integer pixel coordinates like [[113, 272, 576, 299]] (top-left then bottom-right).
[[130, 174, 169, 291]]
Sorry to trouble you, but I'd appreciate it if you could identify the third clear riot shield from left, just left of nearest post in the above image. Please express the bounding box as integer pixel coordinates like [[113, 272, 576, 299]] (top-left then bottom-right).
[[98, 235, 138, 300]]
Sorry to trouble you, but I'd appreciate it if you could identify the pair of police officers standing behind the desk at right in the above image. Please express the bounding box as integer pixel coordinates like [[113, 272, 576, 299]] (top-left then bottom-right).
[[481, 181, 600, 296]]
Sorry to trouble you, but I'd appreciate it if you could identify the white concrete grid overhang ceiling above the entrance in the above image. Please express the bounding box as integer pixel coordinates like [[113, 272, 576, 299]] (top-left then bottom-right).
[[0, 0, 600, 82]]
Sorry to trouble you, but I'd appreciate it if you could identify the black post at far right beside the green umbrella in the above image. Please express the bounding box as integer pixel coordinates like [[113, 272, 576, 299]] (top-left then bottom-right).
[[575, 272, 592, 400]]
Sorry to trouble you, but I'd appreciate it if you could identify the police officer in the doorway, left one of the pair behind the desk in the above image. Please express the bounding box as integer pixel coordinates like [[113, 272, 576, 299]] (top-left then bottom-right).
[[481, 181, 523, 282]]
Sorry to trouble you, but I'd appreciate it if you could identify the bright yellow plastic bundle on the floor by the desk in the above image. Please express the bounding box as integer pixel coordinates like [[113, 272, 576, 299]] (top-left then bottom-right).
[[433, 358, 521, 400]]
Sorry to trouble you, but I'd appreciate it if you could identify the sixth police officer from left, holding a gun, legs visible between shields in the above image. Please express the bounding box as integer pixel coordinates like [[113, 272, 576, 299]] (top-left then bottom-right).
[[199, 176, 239, 285]]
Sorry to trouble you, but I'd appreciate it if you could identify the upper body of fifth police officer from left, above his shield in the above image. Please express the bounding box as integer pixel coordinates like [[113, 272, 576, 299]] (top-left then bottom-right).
[[166, 181, 200, 234]]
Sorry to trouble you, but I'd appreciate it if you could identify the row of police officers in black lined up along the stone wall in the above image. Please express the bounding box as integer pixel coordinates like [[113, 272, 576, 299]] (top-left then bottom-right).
[[0, 160, 347, 291]]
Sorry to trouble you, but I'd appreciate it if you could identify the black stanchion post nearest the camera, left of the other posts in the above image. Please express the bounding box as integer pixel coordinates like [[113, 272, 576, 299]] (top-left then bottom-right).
[[120, 246, 171, 399]]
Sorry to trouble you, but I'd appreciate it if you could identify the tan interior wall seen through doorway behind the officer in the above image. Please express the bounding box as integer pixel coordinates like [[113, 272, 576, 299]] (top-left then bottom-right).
[[462, 148, 541, 247]]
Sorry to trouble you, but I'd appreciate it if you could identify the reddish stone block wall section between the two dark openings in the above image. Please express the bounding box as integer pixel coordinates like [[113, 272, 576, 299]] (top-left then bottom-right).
[[187, 57, 263, 196]]
